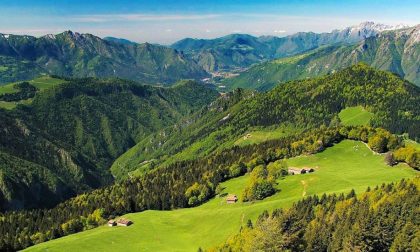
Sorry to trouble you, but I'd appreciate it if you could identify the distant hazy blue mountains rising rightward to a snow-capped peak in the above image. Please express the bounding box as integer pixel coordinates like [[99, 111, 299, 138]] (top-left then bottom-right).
[[171, 22, 410, 71]]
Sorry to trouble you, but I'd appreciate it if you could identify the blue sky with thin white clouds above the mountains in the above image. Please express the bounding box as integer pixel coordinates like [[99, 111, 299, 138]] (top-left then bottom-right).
[[0, 0, 420, 44]]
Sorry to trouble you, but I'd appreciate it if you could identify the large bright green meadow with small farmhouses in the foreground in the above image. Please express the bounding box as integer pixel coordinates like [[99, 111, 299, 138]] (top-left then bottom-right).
[[27, 140, 416, 251]]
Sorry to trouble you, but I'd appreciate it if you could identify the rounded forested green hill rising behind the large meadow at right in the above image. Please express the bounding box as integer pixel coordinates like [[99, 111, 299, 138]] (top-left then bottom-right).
[[113, 64, 420, 176]]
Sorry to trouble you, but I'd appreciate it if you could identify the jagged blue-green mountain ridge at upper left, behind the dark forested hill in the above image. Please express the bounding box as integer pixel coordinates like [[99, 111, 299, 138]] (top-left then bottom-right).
[[0, 31, 207, 84]]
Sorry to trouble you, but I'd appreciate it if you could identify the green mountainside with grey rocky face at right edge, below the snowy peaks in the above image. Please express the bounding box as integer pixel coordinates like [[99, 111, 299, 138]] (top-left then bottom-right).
[[224, 25, 420, 90]]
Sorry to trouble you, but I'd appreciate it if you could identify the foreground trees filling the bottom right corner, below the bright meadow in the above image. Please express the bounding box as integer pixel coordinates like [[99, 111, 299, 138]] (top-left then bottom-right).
[[213, 177, 420, 251]]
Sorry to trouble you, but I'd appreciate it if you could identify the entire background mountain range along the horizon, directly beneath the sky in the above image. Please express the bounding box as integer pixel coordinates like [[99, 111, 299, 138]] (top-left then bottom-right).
[[0, 22, 419, 90]]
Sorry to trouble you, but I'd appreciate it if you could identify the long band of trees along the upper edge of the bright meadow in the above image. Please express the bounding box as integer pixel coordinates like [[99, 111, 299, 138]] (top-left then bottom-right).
[[0, 127, 420, 250]]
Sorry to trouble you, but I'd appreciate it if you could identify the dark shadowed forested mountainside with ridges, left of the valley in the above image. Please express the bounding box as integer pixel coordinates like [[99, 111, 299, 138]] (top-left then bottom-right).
[[0, 78, 218, 209]]
